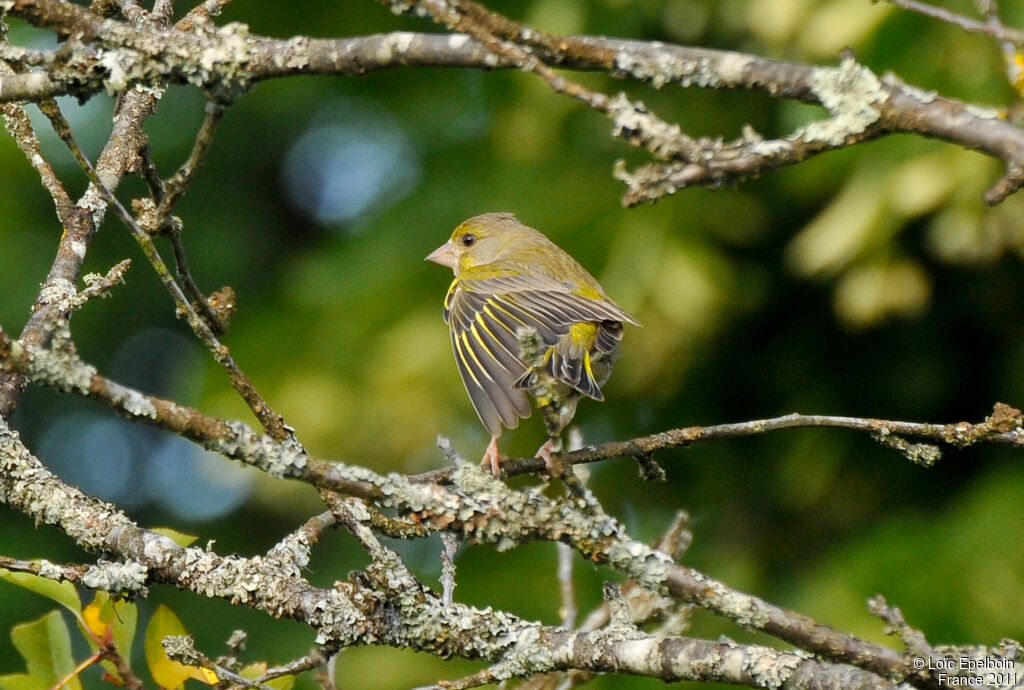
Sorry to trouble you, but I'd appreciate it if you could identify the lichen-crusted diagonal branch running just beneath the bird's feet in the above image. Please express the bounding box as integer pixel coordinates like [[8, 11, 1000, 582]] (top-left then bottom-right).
[[0, 325, 925, 676]]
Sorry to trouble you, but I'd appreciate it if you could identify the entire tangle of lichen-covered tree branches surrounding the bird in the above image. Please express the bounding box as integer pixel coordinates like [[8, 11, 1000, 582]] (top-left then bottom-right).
[[0, 0, 1024, 688]]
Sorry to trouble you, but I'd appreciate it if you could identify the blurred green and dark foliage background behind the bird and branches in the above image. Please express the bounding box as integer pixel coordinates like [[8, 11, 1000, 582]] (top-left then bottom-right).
[[0, 0, 1024, 688]]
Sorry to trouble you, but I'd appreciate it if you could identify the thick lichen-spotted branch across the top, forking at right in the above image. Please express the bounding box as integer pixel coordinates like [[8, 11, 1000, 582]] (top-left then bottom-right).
[[6, 0, 1024, 204]]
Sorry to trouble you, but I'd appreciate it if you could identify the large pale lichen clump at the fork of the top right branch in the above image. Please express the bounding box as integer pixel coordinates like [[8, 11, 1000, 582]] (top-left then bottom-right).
[[797, 57, 889, 146]]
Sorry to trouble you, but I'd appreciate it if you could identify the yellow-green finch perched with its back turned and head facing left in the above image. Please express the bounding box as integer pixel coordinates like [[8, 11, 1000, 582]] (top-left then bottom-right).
[[426, 213, 639, 476]]
